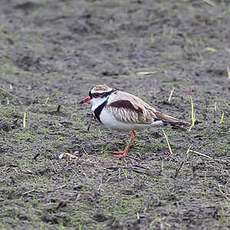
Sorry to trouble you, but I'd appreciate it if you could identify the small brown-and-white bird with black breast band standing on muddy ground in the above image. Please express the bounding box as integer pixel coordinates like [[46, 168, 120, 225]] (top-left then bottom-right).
[[79, 84, 190, 158]]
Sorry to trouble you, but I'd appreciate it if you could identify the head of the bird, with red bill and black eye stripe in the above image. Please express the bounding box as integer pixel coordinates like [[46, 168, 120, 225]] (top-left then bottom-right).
[[79, 85, 115, 110]]
